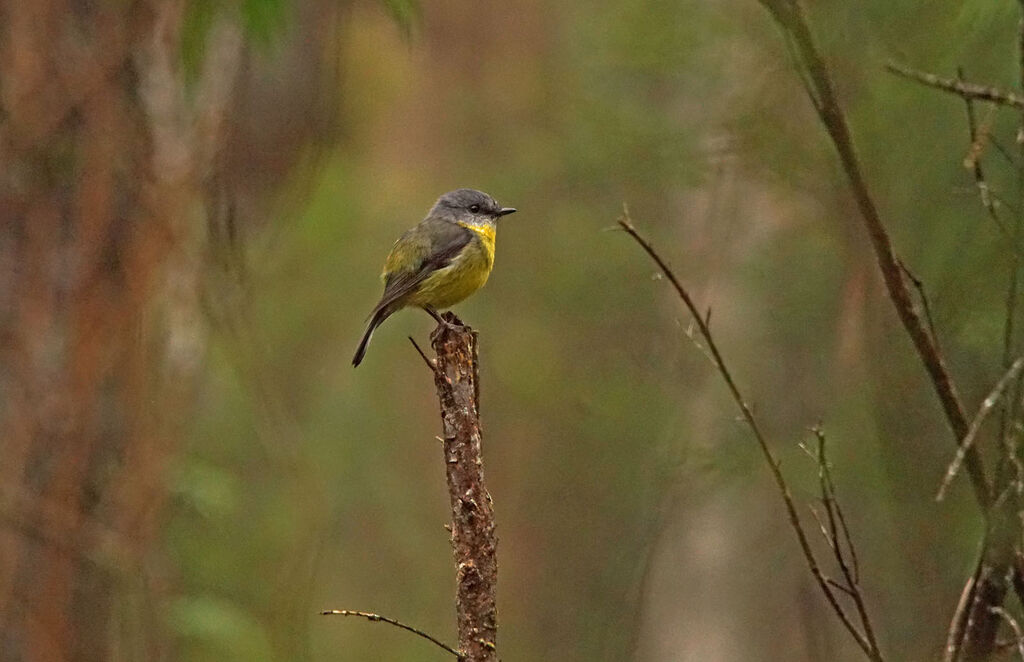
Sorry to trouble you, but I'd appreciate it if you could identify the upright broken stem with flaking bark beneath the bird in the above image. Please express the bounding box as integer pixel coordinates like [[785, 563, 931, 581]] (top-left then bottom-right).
[[431, 313, 498, 662]]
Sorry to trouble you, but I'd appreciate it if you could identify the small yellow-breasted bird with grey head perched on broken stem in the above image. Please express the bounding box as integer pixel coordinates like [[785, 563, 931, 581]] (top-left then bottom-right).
[[352, 189, 515, 366]]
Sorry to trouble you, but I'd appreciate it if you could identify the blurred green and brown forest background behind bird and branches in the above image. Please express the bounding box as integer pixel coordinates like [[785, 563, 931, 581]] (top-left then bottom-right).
[[0, 0, 1019, 662]]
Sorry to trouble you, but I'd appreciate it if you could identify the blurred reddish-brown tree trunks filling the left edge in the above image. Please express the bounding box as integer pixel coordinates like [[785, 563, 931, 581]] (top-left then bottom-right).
[[0, 0, 242, 660]]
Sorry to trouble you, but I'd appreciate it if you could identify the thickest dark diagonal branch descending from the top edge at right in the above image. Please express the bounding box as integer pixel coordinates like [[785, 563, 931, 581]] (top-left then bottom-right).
[[759, 0, 991, 511]]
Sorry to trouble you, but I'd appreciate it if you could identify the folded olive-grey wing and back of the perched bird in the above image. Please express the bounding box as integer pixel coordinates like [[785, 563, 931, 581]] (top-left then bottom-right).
[[374, 218, 473, 312]]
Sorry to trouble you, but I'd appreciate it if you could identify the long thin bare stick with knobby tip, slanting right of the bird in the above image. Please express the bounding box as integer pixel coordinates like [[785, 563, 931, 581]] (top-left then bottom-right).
[[618, 216, 883, 662]]
